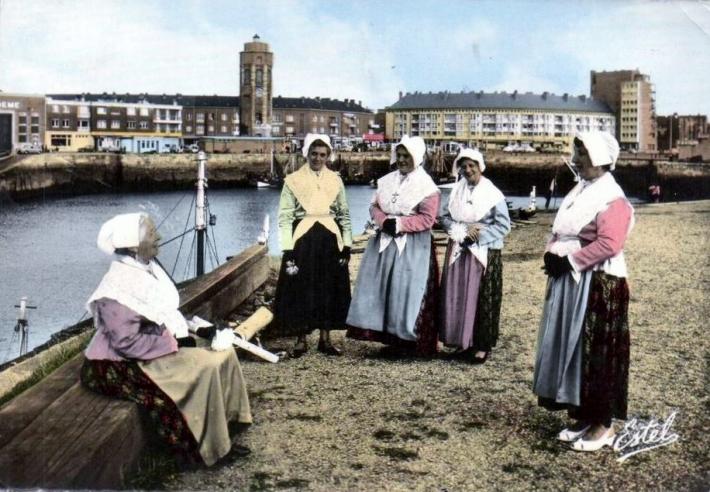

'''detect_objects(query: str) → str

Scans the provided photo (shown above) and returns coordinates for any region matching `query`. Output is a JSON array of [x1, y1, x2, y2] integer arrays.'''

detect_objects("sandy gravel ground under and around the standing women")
[[162, 201, 710, 491]]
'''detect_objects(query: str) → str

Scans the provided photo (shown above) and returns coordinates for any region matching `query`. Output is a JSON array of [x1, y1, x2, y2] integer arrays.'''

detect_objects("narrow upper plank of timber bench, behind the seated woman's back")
[[0, 354, 84, 446]]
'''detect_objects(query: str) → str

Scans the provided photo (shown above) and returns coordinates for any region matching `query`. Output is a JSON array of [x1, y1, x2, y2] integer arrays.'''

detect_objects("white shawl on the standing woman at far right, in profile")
[[547, 172, 634, 282]]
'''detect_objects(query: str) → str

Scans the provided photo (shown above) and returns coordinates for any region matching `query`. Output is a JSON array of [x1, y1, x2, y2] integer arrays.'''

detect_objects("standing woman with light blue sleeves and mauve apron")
[[439, 149, 510, 364]]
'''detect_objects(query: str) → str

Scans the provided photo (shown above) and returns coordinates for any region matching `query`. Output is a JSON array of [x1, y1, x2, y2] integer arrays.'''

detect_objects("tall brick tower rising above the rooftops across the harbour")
[[239, 34, 274, 137]]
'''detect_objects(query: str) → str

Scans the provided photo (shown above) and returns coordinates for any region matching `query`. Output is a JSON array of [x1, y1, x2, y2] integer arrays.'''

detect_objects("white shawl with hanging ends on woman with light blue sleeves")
[[449, 176, 505, 270]]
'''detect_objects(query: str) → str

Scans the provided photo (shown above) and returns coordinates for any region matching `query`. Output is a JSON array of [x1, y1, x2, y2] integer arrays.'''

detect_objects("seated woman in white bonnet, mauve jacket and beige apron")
[[81, 213, 251, 466]]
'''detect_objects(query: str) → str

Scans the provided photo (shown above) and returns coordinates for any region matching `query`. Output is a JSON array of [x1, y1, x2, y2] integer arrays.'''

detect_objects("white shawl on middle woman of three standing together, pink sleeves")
[[373, 167, 439, 254]]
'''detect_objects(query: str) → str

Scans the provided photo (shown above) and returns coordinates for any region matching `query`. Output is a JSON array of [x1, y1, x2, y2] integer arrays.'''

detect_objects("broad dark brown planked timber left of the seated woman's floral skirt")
[[0, 383, 145, 488]]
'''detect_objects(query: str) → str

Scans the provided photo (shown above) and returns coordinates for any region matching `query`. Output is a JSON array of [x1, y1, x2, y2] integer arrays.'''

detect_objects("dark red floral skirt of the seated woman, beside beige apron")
[[81, 359, 202, 463]]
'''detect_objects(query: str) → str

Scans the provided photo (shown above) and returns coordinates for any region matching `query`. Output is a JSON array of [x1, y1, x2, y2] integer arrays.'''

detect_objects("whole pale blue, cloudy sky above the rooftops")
[[0, 0, 710, 114]]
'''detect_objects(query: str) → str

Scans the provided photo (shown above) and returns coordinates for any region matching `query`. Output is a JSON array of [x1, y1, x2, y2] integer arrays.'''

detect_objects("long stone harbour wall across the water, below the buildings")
[[0, 152, 710, 200]]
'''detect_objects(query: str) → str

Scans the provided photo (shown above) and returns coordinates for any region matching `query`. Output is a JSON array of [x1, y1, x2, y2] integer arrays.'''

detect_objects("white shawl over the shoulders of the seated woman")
[[86, 256, 188, 338]]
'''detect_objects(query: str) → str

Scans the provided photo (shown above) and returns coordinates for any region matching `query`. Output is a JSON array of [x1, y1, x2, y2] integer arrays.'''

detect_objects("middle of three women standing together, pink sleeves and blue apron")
[[347, 136, 439, 355]]
